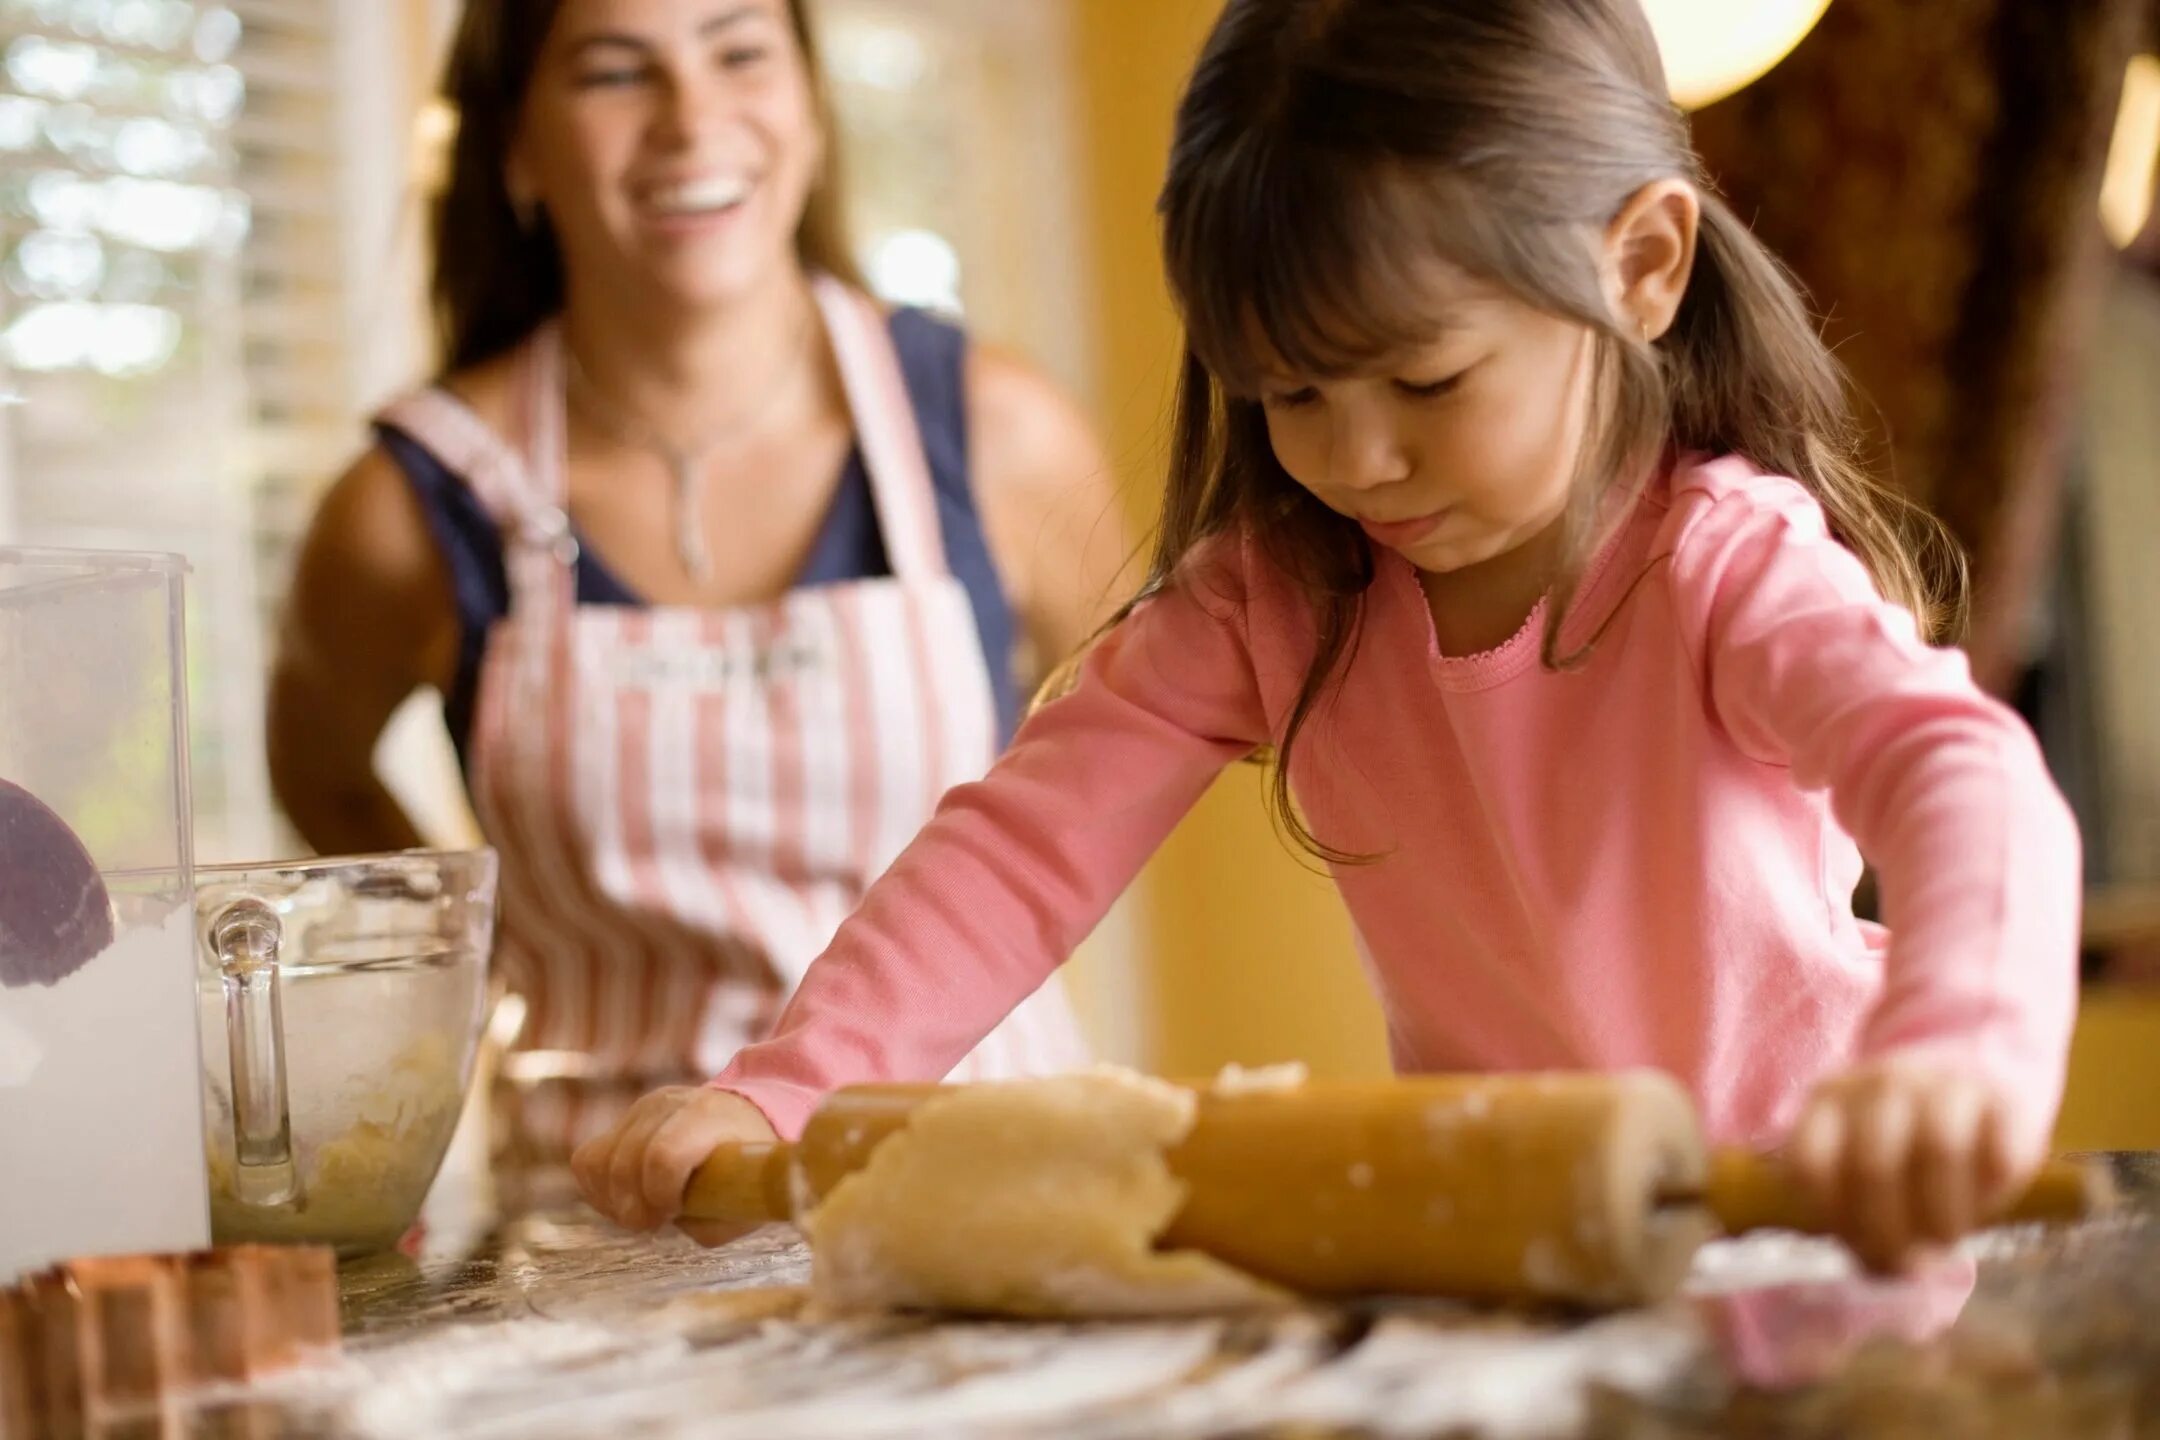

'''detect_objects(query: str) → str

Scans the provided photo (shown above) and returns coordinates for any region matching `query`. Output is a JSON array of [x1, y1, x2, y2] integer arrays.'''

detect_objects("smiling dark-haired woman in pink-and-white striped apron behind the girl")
[[272, 0, 1123, 1159]]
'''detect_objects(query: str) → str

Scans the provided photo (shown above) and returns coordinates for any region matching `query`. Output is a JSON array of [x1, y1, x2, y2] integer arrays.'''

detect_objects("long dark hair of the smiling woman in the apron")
[[430, 0, 858, 371]]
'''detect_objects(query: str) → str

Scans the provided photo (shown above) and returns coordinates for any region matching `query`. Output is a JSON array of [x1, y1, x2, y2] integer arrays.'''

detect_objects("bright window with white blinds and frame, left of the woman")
[[0, 0, 434, 859]]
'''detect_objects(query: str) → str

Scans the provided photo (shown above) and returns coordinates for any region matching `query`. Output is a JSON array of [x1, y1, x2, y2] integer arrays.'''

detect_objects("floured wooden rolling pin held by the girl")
[[683, 1071, 2108, 1306]]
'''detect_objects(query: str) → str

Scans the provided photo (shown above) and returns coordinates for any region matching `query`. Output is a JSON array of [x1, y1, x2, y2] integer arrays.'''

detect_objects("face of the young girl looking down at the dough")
[[1259, 268, 1594, 574]]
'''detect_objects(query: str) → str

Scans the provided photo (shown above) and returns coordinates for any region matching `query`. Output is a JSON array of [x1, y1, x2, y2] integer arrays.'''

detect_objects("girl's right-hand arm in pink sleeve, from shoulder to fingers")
[[1674, 479, 2082, 1259]]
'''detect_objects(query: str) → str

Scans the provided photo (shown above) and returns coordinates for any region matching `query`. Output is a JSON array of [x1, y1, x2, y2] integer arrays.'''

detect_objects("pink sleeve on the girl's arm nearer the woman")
[[713, 542, 1266, 1136]]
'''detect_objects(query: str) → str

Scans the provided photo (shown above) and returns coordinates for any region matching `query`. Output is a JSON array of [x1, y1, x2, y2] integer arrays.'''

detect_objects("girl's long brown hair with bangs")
[[1128, 0, 1963, 861]]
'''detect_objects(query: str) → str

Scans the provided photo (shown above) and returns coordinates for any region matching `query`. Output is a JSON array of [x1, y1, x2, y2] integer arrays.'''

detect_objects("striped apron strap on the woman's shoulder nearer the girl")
[[810, 274, 948, 581]]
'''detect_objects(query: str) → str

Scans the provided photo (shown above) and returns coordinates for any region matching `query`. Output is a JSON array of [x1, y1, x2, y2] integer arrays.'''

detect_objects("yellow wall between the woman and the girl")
[[1071, 0, 1387, 1075]]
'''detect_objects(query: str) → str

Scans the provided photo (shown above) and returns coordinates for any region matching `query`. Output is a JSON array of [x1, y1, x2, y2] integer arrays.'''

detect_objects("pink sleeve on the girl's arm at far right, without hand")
[[1674, 479, 2082, 1153]]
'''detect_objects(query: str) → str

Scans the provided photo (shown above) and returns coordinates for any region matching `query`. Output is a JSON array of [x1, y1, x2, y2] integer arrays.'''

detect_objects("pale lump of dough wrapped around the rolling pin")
[[804, 1069, 1292, 1319]]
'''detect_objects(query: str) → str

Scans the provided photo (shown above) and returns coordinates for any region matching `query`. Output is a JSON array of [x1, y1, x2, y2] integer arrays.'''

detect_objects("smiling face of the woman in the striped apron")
[[505, 0, 825, 307]]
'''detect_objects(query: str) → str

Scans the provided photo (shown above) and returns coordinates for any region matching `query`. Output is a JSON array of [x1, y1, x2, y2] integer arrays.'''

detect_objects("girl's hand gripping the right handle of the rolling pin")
[[1786, 1056, 2043, 1274]]
